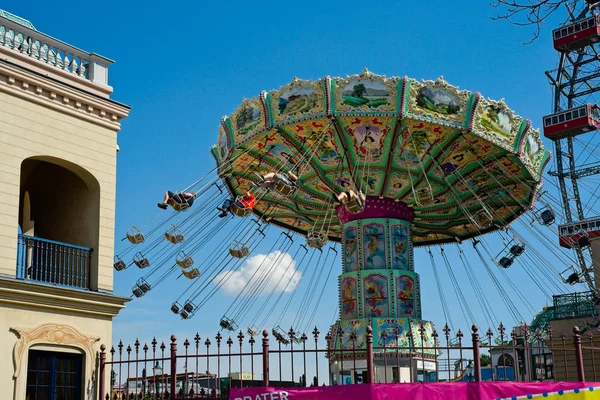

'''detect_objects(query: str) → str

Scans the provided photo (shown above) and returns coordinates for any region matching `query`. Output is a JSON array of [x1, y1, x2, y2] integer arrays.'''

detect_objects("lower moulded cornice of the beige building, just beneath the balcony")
[[0, 277, 130, 318]]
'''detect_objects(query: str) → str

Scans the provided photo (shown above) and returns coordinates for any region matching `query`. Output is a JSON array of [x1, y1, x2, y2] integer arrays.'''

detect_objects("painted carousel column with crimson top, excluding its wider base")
[[337, 197, 421, 320]]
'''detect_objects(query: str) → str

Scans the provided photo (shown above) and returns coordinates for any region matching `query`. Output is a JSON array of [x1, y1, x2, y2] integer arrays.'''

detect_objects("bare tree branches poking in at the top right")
[[490, 0, 585, 44]]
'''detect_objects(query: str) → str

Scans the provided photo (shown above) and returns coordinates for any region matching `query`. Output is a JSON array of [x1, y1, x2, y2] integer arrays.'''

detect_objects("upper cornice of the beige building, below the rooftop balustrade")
[[0, 61, 129, 132]]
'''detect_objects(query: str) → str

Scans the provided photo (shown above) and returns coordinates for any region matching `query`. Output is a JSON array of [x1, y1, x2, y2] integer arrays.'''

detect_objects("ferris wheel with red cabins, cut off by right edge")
[[543, 0, 600, 299]]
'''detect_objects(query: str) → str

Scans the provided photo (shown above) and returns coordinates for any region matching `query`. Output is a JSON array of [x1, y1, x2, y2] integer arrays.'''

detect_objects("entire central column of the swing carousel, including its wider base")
[[330, 197, 436, 383]]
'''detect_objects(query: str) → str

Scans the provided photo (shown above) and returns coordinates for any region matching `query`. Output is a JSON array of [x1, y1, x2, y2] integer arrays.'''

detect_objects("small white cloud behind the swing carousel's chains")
[[216, 251, 302, 295]]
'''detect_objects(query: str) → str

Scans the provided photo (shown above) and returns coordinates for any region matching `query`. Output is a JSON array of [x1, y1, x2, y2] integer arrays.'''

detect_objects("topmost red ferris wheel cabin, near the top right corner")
[[552, 15, 600, 52]]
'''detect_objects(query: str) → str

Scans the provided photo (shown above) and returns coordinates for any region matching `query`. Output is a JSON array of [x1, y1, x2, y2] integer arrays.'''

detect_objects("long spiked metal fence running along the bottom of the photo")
[[99, 324, 600, 400]]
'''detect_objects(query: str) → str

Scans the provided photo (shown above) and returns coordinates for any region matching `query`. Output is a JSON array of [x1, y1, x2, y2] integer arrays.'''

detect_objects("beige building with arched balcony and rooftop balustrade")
[[0, 10, 129, 400]]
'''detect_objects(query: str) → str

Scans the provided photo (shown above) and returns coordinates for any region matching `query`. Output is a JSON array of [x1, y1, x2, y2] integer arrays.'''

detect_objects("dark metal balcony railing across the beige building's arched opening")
[[17, 235, 92, 289]]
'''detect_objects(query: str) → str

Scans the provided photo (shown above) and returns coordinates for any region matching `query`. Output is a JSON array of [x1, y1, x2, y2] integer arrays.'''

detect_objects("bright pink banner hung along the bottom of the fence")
[[229, 382, 600, 400]]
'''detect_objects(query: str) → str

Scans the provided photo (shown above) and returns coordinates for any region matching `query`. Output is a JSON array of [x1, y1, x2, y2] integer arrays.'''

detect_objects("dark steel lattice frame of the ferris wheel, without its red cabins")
[[545, 4, 600, 297]]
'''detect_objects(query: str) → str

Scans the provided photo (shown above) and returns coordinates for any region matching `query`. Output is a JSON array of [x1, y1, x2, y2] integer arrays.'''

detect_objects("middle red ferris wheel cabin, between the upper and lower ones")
[[544, 104, 600, 140]]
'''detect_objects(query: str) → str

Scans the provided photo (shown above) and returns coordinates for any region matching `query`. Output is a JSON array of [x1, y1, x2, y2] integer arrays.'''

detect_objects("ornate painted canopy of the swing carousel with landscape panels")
[[212, 70, 550, 246]]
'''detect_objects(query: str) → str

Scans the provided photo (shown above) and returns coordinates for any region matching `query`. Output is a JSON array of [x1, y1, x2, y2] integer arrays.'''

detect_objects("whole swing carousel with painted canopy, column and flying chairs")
[[114, 70, 596, 357]]
